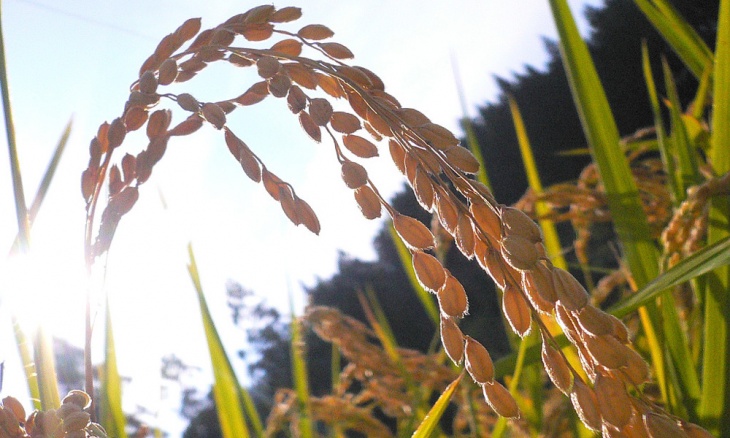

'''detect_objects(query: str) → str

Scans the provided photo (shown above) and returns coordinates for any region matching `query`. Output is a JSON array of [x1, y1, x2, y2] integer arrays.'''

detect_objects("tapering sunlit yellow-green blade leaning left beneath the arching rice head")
[[188, 244, 249, 438]]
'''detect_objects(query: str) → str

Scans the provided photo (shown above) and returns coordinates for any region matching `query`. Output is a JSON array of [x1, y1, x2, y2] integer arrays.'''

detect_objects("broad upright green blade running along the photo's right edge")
[[699, 0, 730, 436]]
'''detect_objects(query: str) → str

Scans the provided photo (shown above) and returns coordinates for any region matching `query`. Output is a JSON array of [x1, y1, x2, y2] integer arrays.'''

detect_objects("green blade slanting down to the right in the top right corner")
[[634, 0, 712, 79]]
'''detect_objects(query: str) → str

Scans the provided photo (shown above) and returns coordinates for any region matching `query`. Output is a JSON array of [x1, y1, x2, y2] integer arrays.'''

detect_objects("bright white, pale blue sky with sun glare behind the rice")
[[0, 0, 601, 434]]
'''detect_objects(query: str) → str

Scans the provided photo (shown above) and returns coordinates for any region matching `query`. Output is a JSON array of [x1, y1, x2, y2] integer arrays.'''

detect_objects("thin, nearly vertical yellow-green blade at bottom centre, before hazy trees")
[[289, 294, 314, 438]]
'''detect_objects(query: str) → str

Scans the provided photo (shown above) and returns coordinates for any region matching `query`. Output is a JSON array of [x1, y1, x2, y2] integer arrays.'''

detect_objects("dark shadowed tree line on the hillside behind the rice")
[[185, 0, 719, 438]]
